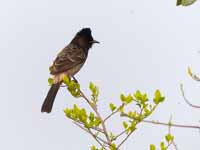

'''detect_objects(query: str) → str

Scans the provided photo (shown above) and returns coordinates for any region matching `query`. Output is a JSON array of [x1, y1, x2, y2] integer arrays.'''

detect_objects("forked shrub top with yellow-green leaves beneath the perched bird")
[[64, 77, 165, 150]]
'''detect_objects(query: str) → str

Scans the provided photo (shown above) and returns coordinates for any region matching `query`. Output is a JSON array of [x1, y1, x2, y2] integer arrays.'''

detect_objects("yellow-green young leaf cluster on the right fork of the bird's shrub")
[[121, 90, 165, 134]]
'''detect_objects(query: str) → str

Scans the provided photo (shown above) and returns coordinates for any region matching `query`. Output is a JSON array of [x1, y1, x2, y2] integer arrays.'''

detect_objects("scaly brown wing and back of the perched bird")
[[50, 44, 87, 75]]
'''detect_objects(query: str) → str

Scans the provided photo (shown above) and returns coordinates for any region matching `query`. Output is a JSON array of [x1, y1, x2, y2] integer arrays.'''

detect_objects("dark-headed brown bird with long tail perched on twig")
[[41, 28, 99, 113]]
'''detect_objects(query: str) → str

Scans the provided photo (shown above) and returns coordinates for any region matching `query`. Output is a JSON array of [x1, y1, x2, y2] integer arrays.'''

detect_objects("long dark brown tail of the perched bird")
[[41, 82, 62, 113]]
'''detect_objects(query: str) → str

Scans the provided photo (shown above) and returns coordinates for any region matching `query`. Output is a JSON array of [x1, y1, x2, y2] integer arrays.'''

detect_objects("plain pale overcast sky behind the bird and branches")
[[0, 0, 200, 150]]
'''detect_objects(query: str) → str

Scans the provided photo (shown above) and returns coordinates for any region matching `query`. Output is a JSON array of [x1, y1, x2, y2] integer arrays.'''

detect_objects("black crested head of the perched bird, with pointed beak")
[[71, 28, 99, 50]]
